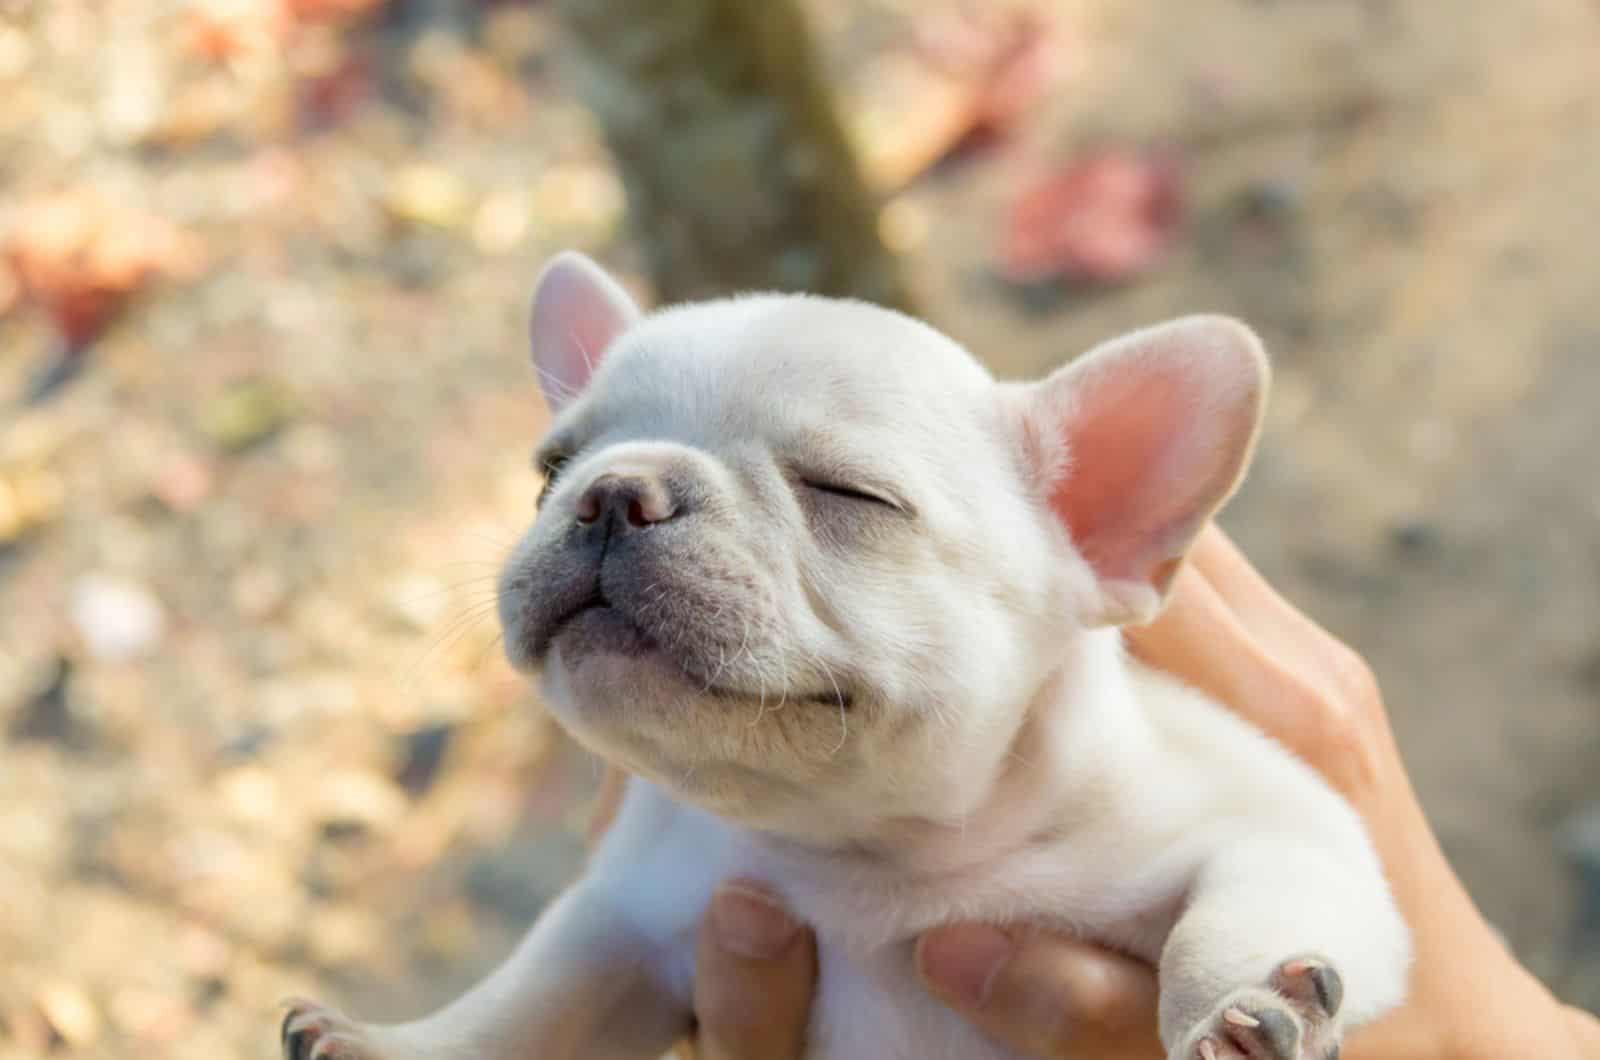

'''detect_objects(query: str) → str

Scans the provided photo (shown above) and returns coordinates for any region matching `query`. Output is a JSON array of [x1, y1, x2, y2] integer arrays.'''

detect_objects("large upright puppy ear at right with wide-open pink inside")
[[1026, 315, 1269, 624]]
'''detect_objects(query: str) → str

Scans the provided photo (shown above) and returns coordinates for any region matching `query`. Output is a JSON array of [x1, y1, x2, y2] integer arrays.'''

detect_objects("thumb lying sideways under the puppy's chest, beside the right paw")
[[917, 924, 1165, 1060]]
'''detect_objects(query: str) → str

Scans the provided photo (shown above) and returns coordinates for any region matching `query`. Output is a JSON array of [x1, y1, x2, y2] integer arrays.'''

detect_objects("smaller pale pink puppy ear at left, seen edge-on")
[[528, 250, 638, 413]]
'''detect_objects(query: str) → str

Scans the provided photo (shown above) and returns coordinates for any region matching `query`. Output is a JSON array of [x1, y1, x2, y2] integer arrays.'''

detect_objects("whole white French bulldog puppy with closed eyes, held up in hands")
[[283, 253, 1410, 1060]]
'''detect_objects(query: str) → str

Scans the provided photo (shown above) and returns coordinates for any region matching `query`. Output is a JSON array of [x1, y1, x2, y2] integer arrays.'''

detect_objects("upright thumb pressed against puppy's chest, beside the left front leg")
[[694, 881, 816, 1060]]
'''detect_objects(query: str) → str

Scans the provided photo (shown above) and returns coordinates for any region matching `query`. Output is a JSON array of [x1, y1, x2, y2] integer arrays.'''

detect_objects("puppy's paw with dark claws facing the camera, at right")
[[1173, 956, 1344, 1060]]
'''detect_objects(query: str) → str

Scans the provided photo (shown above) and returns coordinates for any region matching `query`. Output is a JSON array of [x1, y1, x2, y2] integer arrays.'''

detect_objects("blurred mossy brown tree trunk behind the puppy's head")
[[560, 0, 910, 309]]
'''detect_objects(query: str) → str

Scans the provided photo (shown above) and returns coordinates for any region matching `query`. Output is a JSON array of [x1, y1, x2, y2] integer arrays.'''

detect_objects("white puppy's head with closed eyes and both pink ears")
[[499, 255, 1266, 841]]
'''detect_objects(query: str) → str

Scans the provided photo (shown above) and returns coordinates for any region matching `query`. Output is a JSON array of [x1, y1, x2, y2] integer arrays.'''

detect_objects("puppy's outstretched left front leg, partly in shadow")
[[282, 877, 690, 1060]]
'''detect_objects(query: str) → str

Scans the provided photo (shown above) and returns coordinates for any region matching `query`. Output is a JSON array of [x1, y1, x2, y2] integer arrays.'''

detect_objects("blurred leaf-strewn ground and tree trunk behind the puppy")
[[0, 0, 1600, 1060]]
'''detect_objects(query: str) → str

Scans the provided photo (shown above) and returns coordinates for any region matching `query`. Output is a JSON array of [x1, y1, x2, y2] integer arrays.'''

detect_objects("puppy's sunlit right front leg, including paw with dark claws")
[[1160, 837, 1410, 1060]]
